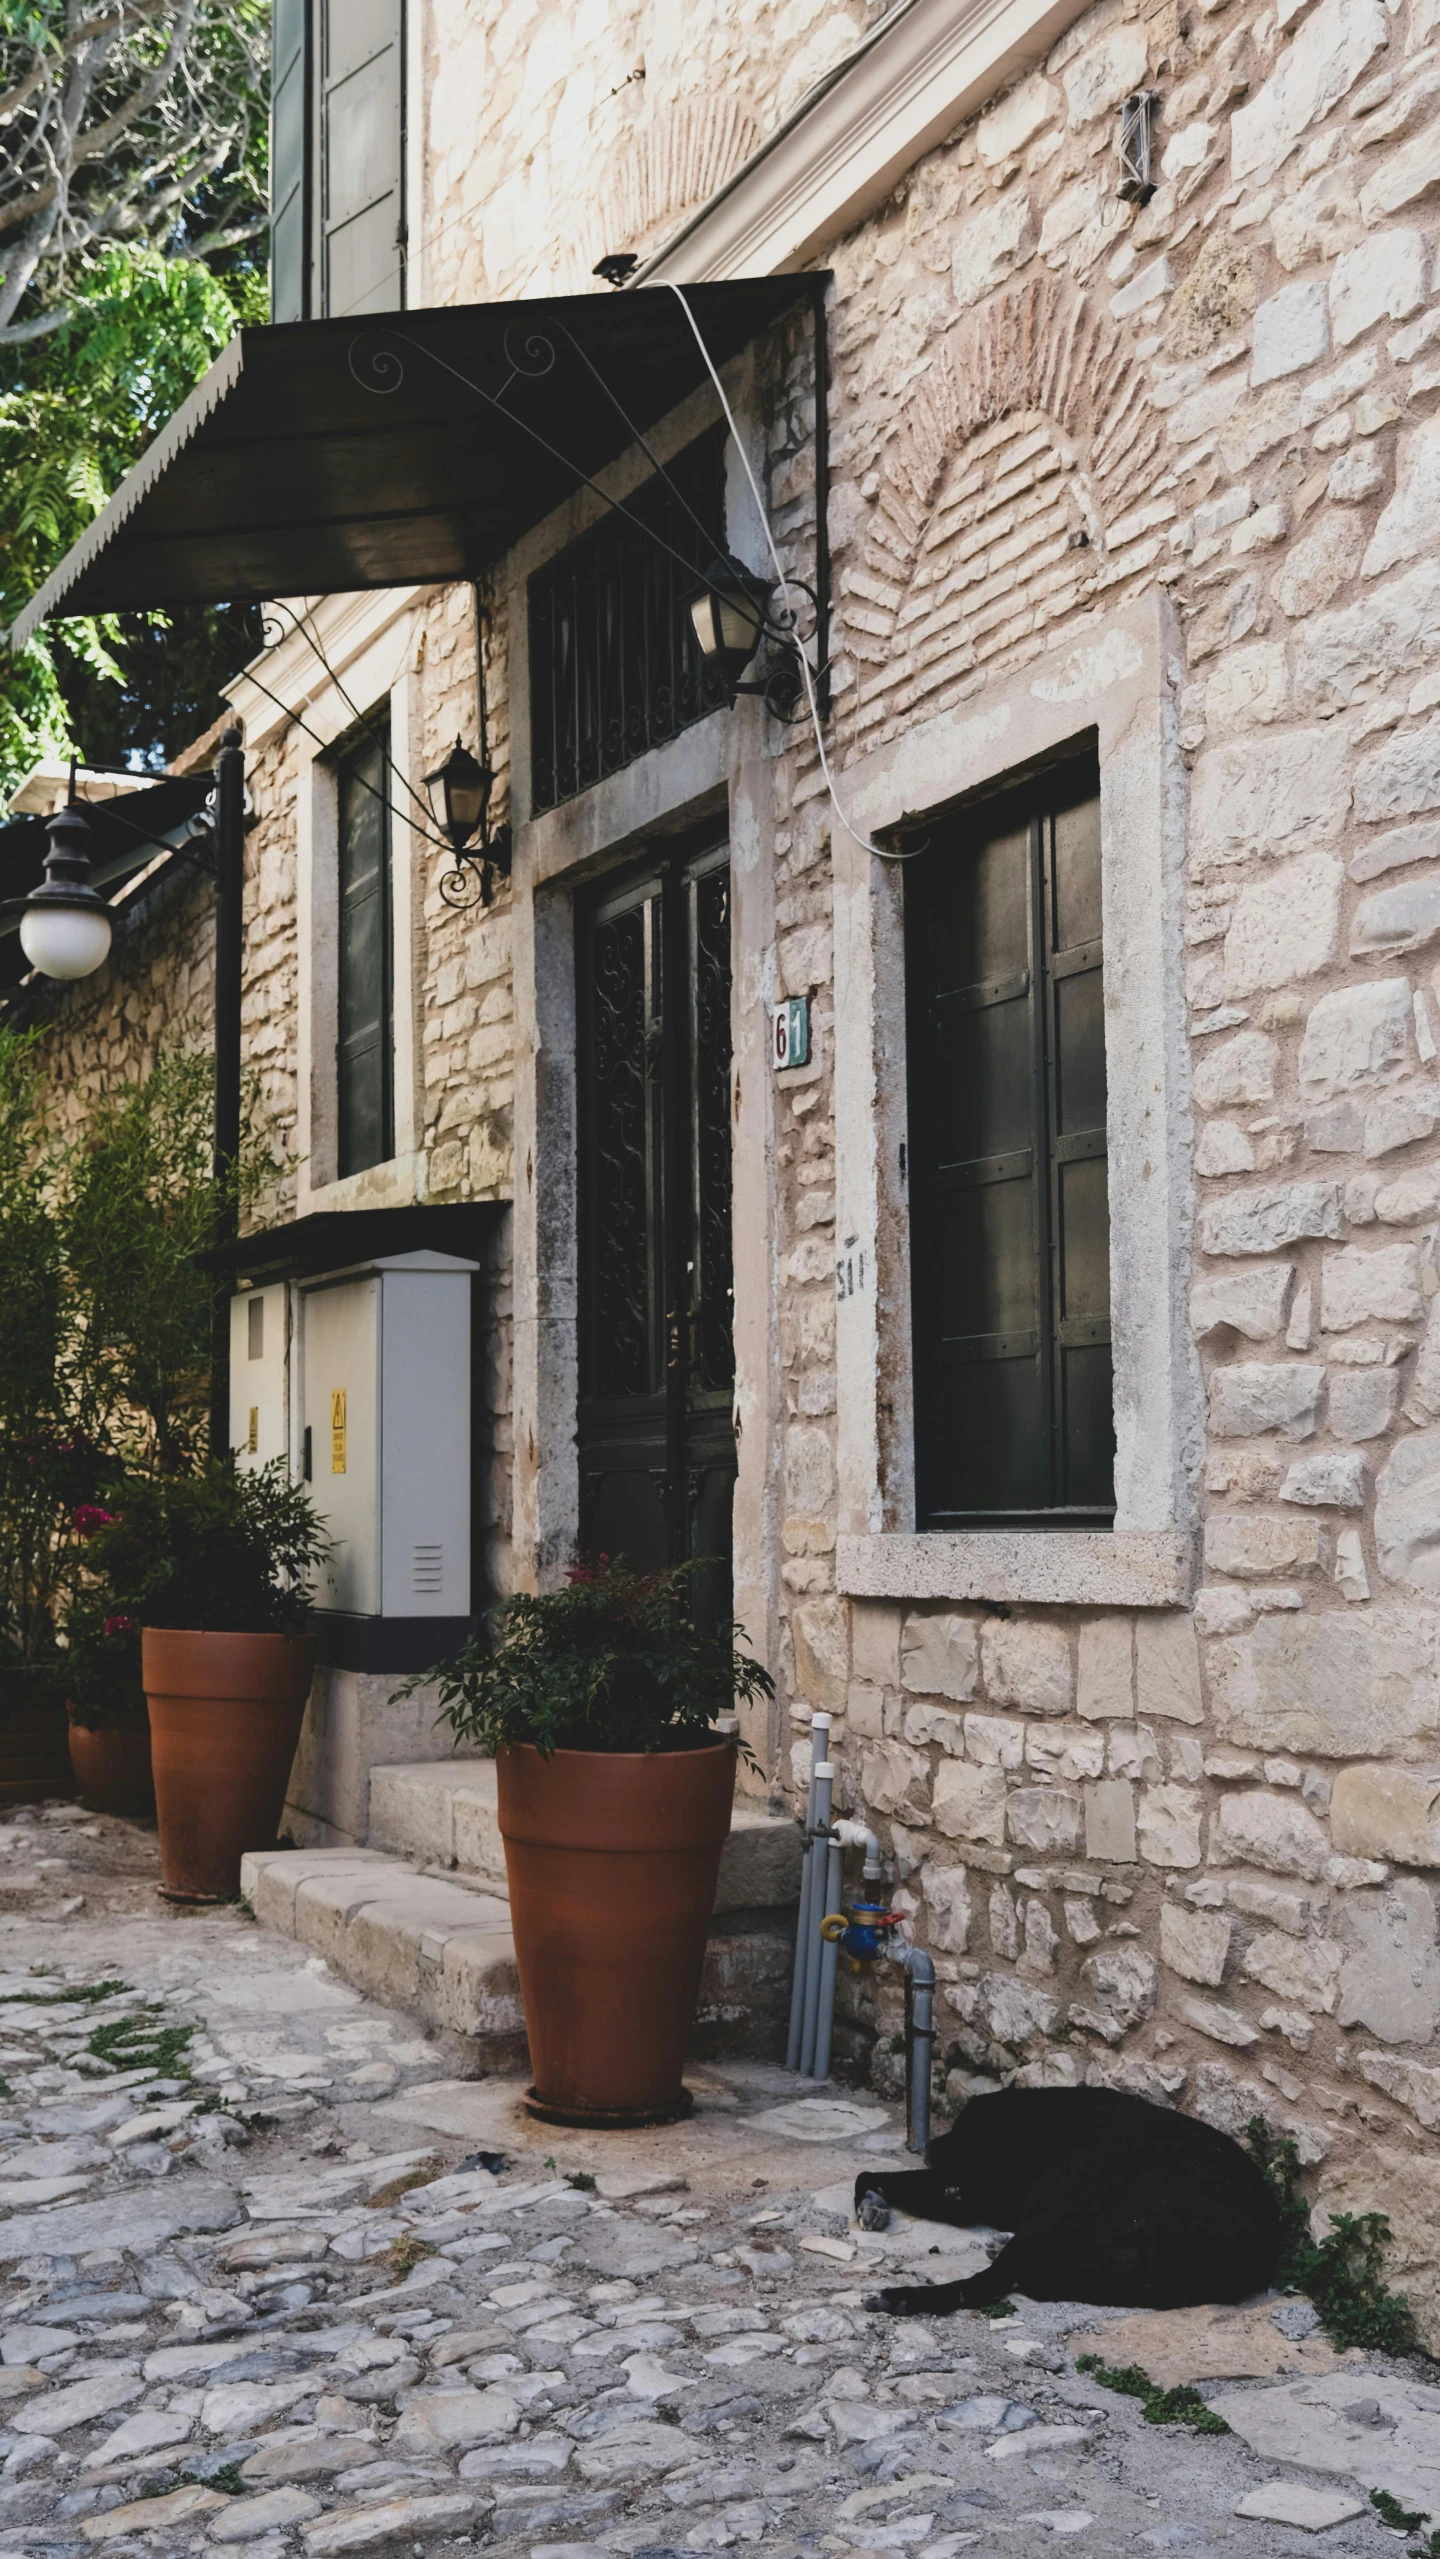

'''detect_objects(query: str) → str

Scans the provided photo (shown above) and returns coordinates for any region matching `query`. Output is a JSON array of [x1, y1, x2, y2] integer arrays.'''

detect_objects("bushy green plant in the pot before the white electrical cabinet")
[[87, 1459, 330, 1635]]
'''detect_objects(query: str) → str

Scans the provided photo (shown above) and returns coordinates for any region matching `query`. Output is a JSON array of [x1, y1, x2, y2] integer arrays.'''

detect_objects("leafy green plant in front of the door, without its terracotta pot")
[[399, 1556, 775, 1758]]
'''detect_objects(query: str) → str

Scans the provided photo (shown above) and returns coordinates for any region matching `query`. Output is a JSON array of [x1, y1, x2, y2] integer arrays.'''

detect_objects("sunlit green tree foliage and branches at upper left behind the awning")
[[0, 0, 271, 796]]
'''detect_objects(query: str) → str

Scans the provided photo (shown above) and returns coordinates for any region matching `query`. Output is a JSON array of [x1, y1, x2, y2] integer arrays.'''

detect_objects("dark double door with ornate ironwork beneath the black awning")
[[575, 842, 734, 1617]]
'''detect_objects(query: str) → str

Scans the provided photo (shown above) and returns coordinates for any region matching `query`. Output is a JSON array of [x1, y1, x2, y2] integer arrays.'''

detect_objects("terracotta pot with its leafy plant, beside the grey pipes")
[[412, 1556, 775, 2127]]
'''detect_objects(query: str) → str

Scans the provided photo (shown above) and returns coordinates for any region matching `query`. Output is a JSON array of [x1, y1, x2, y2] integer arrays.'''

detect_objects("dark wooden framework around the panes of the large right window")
[[903, 737, 1115, 1535]]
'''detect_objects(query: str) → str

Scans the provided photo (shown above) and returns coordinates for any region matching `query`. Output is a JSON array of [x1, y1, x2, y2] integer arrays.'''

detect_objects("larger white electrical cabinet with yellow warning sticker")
[[299, 1251, 476, 1617]]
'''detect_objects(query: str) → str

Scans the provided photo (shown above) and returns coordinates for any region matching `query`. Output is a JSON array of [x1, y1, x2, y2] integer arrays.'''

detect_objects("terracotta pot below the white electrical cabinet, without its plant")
[[141, 1625, 315, 1901]]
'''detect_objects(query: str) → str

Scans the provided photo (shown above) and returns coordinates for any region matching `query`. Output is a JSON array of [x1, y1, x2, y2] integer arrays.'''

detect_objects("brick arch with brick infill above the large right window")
[[841, 274, 1166, 752]]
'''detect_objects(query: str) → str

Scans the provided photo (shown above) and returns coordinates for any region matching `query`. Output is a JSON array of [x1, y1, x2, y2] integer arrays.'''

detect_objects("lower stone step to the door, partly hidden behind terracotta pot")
[[240, 1848, 795, 2070]]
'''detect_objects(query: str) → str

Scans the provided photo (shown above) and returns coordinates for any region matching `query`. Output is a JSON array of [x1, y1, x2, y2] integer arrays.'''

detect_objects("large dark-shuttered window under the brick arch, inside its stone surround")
[[905, 757, 1120, 1528]]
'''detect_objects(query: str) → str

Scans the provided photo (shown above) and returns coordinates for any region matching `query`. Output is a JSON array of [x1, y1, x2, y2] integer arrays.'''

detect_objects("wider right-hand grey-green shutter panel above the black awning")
[[320, 0, 404, 320]]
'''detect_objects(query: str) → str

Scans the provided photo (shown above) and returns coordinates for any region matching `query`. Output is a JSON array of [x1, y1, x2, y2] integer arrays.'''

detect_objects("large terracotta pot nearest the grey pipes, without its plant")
[[496, 1743, 734, 2127]]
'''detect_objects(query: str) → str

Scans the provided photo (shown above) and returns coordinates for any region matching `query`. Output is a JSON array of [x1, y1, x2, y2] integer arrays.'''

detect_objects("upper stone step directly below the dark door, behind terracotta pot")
[[368, 1758, 801, 1912]]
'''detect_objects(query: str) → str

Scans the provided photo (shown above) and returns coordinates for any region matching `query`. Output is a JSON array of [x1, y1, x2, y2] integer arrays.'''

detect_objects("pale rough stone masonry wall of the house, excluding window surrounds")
[[19, 0, 1440, 2344]]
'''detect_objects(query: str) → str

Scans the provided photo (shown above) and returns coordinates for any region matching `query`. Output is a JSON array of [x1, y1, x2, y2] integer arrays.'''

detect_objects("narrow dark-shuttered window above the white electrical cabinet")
[[335, 729, 394, 1175]]
